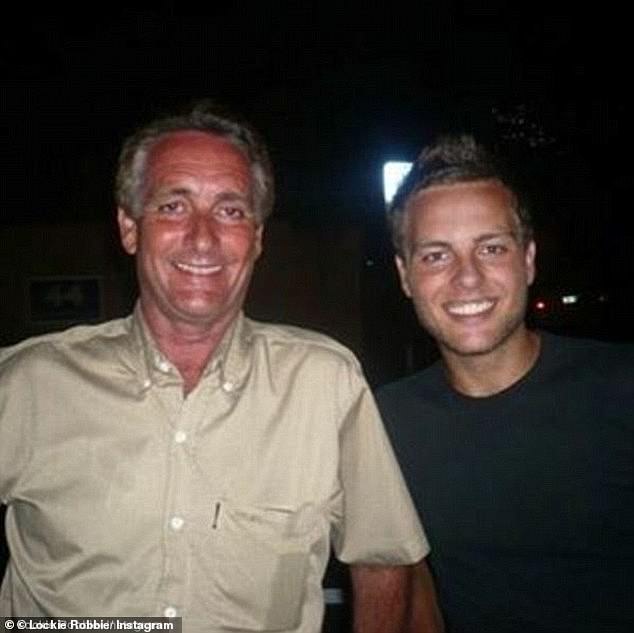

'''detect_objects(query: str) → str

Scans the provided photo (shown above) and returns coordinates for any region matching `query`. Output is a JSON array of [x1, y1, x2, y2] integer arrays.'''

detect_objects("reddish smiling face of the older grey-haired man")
[[119, 131, 262, 332]]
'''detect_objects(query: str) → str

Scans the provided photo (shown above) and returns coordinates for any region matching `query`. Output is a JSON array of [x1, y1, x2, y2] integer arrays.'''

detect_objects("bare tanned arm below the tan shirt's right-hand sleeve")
[[351, 561, 444, 633]]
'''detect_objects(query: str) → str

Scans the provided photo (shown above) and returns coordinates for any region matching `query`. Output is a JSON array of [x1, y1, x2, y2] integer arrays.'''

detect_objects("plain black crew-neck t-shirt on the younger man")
[[377, 333, 634, 633]]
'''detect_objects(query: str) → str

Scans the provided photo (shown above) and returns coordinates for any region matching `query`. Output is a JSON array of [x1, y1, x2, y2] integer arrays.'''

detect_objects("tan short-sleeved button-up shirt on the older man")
[[0, 310, 427, 633]]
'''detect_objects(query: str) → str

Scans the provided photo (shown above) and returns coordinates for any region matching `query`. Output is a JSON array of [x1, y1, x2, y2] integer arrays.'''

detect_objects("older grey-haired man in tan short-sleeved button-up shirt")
[[0, 104, 435, 633]]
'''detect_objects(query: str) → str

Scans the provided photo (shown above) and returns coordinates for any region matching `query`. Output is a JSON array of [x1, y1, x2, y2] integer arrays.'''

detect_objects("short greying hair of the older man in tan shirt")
[[115, 99, 275, 222]]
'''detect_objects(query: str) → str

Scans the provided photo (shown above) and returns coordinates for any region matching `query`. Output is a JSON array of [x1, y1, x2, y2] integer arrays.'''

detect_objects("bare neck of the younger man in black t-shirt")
[[443, 327, 541, 398]]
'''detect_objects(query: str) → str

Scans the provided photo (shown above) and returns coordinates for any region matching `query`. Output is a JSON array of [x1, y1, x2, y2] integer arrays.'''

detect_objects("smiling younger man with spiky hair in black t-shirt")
[[379, 137, 634, 633]]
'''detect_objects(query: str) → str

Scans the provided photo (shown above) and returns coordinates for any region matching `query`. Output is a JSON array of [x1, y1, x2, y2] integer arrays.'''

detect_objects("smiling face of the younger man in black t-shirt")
[[396, 180, 535, 357]]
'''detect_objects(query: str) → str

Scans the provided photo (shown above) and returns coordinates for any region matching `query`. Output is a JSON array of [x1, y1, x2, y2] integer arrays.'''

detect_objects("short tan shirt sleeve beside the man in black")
[[333, 360, 429, 565]]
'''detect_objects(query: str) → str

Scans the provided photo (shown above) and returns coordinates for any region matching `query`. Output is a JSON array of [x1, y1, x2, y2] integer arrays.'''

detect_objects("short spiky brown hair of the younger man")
[[387, 134, 533, 255]]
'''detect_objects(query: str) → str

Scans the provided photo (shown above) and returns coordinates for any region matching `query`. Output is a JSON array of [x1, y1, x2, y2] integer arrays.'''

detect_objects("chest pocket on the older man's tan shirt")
[[214, 502, 316, 631]]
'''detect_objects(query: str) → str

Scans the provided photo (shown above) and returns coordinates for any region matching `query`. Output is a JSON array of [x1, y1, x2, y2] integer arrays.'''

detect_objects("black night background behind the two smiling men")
[[0, 0, 634, 628]]
